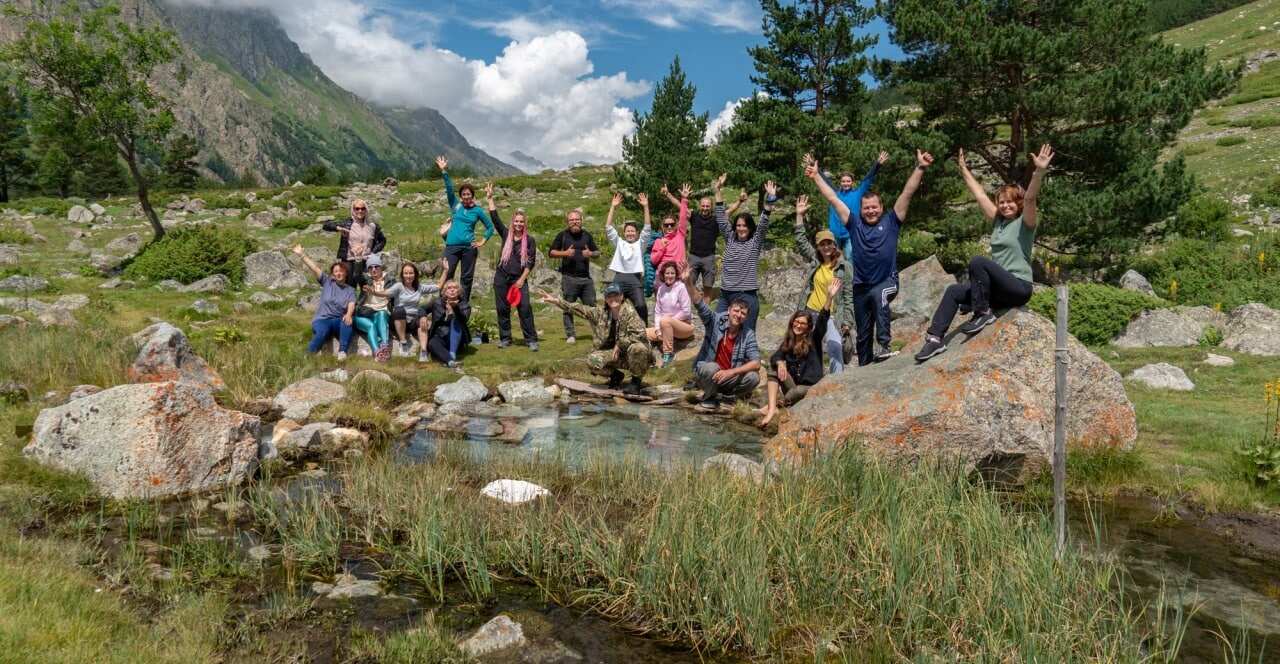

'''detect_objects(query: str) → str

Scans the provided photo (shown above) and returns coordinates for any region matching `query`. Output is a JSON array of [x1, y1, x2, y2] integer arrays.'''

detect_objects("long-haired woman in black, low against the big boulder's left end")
[[759, 278, 841, 427]]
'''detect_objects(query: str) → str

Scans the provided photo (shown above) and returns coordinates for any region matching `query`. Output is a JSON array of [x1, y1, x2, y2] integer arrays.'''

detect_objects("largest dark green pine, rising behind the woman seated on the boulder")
[[883, 0, 1238, 261]]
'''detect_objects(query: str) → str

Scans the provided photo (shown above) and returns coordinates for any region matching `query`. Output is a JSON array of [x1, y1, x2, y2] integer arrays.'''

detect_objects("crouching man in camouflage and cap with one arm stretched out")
[[538, 284, 653, 394]]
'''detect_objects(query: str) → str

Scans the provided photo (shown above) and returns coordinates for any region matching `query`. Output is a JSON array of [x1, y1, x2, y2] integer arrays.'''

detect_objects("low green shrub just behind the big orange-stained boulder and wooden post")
[[1028, 284, 1162, 345]]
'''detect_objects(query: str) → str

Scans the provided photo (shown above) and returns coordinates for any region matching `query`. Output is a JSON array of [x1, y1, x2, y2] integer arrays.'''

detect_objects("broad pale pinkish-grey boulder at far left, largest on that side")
[[23, 381, 259, 499]]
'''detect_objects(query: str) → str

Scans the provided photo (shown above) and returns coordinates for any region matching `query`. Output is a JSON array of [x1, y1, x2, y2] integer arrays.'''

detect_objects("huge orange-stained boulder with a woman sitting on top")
[[765, 310, 1138, 481]]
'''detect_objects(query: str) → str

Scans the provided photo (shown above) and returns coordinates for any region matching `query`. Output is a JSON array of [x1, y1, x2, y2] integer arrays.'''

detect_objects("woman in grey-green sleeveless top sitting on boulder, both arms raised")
[[915, 143, 1053, 362]]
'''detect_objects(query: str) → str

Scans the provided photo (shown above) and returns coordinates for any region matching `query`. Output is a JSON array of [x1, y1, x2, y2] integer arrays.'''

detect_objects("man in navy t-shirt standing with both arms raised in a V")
[[805, 150, 933, 366]]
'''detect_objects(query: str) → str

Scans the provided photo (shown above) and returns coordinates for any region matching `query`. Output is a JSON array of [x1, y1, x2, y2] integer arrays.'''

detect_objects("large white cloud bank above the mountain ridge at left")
[[163, 0, 650, 168]]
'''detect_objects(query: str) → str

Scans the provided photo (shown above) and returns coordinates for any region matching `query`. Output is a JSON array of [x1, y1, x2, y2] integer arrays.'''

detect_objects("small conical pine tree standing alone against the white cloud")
[[614, 58, 708, 206]]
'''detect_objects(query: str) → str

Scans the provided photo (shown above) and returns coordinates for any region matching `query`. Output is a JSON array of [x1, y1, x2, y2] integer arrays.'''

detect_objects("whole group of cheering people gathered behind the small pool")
[[302, 145, 1053, 426]]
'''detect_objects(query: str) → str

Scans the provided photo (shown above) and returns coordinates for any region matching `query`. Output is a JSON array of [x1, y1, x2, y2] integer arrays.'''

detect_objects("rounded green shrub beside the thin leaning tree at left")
[[124, 225, 256, 285]]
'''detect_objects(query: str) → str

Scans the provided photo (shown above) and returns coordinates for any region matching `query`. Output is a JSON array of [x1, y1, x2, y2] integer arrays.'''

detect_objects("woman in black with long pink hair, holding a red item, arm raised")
[[484, 182, 538, 353]]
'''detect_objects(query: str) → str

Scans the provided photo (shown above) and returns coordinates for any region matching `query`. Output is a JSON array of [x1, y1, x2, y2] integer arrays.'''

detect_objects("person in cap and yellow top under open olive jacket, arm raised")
[[792, 194, 854, 374]]
